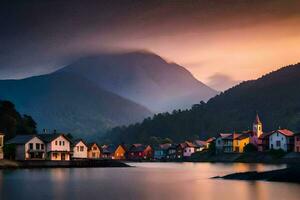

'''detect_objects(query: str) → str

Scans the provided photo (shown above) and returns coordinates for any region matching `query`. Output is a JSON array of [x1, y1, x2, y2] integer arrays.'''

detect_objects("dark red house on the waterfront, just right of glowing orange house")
[[128, 144, 153, 160]]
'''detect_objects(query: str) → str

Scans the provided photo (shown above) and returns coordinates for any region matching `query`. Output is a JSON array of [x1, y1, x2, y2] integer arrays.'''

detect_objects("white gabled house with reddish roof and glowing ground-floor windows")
[[39, 133, 71, 160]]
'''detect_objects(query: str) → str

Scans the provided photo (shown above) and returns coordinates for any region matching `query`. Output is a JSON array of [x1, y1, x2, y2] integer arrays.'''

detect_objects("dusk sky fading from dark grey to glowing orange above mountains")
[[0, 0, 300, 91]]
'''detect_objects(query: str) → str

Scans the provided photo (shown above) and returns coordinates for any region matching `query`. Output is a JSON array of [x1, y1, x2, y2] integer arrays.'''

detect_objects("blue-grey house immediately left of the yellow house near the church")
[[216, 133, 233, 154]]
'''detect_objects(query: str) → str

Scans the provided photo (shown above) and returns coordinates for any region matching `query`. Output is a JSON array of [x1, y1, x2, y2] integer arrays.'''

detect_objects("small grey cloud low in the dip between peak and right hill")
[[207, 73, 240, 91]]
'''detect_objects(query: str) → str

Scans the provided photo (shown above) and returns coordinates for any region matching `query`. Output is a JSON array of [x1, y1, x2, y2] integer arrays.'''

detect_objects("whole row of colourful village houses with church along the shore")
[[0, 115, 300, 161]]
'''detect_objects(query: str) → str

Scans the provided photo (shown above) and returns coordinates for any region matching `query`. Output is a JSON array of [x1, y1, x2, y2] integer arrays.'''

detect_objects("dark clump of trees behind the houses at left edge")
[[0, 100, 37, 140]]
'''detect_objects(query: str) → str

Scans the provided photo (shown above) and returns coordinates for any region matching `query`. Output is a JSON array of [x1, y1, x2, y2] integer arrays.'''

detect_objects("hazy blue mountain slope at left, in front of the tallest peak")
[[0, 73, 151, 138]]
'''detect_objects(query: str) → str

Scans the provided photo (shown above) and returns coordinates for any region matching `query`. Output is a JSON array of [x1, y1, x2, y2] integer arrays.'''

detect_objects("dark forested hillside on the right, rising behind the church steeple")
[[106, 64, 300, 143]]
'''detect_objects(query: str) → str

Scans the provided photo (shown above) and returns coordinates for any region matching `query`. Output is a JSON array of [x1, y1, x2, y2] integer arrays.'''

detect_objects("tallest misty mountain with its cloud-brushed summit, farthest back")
[[57, 52, 217, 112]]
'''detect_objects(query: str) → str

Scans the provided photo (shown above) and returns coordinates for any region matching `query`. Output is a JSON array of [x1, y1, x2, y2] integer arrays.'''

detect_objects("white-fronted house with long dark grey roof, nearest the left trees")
[[6, 135, 46, 160]]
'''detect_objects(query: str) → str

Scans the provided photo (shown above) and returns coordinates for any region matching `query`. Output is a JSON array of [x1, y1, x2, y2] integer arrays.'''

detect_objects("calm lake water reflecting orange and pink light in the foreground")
[[0, 163, 300, 200]]
